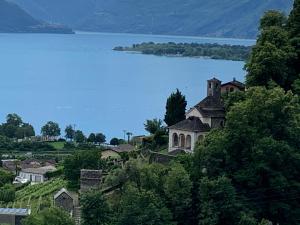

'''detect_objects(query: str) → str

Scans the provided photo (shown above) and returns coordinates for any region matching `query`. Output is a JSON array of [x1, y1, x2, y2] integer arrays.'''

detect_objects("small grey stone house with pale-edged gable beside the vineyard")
[[54, 188, 75, 216]]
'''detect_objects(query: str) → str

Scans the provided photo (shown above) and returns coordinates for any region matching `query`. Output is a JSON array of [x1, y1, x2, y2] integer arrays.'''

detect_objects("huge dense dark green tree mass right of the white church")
[[193, 87, 300, 224]]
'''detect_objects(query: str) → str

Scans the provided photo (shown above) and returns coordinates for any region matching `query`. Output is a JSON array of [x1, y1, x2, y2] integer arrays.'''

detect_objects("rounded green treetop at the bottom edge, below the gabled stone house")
[[22, 208, 75, 225]]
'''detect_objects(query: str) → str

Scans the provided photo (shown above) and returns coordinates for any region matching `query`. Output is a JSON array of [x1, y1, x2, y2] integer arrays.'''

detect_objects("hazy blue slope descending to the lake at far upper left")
[[0, 0, 72, 33]]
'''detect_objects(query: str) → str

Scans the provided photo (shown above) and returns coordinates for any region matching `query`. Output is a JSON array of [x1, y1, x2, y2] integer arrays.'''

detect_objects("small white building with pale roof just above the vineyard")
[[19, 166, 56, 183]]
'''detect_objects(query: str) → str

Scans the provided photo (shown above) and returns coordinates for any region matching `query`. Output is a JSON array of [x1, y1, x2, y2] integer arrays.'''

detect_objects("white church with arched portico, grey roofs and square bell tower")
[[169, 78, 225, 153]]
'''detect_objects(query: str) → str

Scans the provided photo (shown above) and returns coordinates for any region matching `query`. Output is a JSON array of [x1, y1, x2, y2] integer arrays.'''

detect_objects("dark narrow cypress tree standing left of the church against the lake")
[[165, 89, 187, 126]]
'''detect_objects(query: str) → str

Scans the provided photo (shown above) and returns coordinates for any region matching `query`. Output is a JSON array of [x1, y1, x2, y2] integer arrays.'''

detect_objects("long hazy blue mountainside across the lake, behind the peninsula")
[[11, 0, 293, 38]]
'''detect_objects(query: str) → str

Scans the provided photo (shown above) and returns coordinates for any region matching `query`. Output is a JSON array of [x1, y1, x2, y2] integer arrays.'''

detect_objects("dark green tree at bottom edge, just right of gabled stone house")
[[80, 192, 113, 225]]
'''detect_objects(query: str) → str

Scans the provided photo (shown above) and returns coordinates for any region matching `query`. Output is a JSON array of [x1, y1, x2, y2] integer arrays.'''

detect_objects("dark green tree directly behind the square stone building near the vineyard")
[[63, 150, 104, 189]]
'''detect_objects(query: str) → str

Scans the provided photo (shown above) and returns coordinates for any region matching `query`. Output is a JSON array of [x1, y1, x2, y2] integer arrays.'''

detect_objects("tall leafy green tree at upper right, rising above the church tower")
[[245, 11, 297, 90]]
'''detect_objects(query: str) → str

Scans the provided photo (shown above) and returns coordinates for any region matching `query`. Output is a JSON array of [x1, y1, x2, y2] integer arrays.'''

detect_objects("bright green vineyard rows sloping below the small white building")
[[0, 178, 67, 213]]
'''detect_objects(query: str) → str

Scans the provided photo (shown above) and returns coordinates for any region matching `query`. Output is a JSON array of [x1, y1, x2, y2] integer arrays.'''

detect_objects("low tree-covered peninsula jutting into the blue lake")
[[114, 42, 251, 61]]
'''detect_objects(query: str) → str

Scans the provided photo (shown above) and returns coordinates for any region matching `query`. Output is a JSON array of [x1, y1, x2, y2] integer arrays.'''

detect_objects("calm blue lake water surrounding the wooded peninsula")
[[0, 32, 255, 140]]
